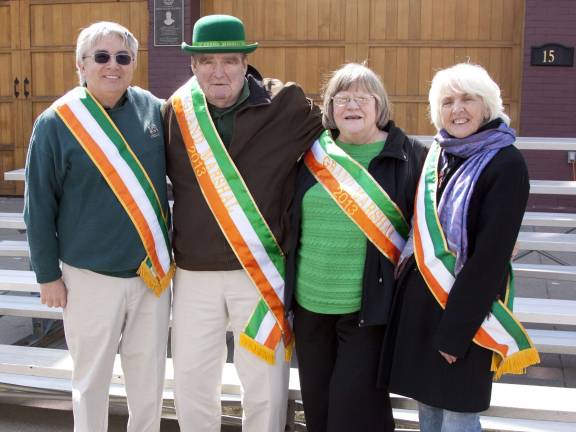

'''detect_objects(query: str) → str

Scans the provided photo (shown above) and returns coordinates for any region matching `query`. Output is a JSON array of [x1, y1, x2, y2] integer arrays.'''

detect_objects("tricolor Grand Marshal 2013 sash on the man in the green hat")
[[172, 77, 292, 364]]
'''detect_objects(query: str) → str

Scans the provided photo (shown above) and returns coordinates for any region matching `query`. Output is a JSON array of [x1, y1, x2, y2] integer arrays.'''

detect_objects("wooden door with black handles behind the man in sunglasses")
[[0, 0, 148, 193]]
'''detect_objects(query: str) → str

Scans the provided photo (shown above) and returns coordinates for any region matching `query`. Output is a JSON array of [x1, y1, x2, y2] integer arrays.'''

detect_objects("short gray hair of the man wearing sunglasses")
[[76, 21, 138, 85]]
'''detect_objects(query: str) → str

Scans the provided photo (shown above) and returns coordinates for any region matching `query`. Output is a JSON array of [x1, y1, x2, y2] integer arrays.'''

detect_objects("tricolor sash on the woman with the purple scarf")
[[414, 142, 540, 379]]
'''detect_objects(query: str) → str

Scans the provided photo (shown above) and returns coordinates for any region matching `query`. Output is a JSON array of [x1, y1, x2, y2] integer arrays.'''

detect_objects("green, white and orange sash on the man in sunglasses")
[[52, 87, 175, 296]]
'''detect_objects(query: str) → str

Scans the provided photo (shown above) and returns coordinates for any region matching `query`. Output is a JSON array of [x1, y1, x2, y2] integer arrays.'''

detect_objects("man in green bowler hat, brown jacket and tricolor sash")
[[164, 15, 322, 432]]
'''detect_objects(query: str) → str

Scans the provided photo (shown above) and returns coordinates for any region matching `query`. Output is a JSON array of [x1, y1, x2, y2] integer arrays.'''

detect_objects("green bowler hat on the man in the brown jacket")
[[182, 15, 258, 54]]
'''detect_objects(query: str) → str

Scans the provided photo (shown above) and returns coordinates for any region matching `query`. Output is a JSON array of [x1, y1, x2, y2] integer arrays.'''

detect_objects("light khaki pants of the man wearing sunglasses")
[[62, 264, 170, 432]]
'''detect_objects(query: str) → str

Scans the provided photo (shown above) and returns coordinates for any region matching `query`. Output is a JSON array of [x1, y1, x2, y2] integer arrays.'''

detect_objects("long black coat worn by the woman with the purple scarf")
[[380, 146, 530, 412]]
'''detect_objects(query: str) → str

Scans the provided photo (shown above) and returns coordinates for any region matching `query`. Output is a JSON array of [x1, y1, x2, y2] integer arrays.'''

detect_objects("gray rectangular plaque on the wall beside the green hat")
[[154, 0, 184, 46]]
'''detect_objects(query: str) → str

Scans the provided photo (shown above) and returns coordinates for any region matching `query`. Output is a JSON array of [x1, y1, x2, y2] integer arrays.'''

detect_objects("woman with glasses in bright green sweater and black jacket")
[[286, 63, 424, 432]]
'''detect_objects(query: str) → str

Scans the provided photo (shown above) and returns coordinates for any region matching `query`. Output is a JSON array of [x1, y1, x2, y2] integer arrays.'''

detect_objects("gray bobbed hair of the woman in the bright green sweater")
[[322, 63, 390, 129]]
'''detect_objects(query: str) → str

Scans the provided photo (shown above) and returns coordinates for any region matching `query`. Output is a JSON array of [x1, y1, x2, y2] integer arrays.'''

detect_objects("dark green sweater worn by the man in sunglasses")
[[24, 87, 168, 283]]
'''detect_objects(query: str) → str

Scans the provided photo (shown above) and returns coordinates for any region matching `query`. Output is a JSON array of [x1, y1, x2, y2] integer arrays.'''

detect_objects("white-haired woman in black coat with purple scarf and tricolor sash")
[[380, 64, 538, 432]]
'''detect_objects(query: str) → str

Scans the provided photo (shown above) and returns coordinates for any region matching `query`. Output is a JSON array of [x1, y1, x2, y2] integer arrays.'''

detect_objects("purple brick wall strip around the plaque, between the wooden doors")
[[148, 0, 200, 98]]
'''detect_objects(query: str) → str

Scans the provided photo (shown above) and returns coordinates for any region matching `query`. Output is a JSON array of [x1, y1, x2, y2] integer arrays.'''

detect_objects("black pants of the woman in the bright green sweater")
[[294, 305, 394, 432]]
